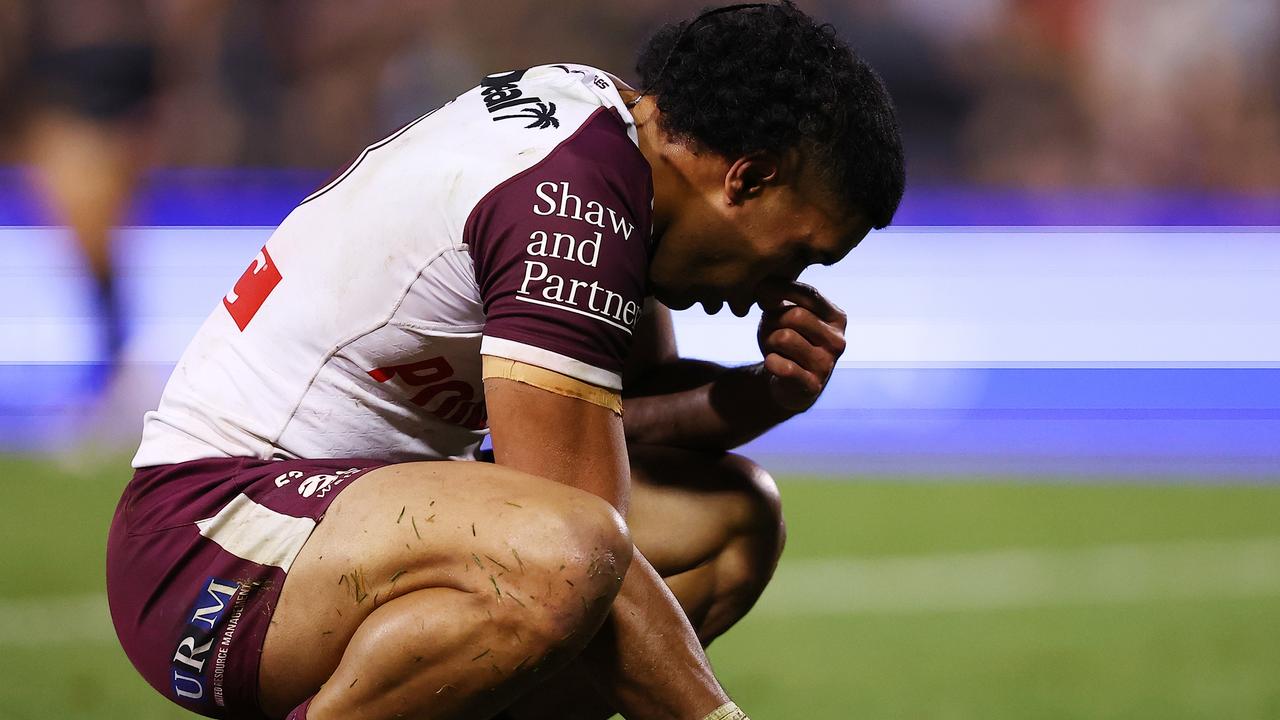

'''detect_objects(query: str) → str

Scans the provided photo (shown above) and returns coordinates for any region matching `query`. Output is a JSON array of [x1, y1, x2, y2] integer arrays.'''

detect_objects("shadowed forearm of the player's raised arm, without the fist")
[[622, 360, 795, 450]]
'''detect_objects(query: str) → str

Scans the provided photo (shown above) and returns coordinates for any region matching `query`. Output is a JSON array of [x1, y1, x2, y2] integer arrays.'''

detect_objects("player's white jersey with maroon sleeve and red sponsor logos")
[[133, 65, 653, 468]]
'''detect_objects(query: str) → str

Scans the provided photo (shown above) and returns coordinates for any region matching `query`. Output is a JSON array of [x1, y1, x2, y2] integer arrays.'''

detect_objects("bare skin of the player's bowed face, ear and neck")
[[621, 90, 872, 322]]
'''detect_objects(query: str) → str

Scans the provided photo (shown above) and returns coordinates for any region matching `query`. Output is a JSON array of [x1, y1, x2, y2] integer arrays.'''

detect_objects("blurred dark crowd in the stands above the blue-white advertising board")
[[0, 0, 1280, 190]]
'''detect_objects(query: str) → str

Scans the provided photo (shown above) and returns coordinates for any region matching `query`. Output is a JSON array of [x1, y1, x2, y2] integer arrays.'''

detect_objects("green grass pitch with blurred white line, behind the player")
[[0, 457, 1280, 720]]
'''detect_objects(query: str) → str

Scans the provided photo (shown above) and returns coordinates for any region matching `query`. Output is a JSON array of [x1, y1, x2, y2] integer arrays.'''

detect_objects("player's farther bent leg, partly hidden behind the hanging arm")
[[499, 446, 786, 720]]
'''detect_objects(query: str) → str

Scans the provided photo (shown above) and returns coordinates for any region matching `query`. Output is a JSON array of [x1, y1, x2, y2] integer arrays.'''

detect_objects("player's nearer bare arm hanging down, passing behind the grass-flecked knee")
[[485, 378, 727, 720]]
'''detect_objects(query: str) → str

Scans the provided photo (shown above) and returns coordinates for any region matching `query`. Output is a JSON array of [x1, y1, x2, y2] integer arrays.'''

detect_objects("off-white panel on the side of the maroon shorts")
[[196, 493, 316, 573]]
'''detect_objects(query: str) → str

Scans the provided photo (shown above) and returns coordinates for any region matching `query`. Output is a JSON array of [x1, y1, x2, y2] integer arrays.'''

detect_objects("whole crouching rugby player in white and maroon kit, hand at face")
[[108, 4, 904, 720]]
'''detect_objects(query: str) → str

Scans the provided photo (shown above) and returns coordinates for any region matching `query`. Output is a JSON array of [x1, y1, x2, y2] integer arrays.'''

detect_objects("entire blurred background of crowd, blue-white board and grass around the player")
[[0, 0, 1280, 719]]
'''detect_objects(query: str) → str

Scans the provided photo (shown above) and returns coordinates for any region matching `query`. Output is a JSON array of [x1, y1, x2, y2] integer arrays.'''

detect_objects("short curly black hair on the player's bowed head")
[[636, 0, 906, 228]]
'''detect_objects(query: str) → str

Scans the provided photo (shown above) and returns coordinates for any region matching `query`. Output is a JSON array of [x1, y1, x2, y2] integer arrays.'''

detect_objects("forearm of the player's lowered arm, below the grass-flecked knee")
[[582, 550, 728, 720]]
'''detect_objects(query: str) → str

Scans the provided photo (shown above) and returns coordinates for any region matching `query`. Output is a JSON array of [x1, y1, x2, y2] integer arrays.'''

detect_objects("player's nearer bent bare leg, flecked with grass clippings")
[[260, 462, 631, 720]]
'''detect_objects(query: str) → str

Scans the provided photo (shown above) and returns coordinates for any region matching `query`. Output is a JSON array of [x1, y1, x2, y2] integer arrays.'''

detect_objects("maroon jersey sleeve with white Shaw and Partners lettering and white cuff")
[[463, 109, 653, 391]]
